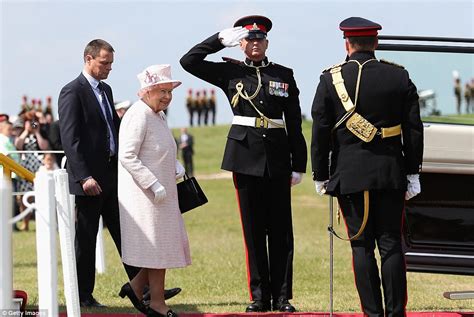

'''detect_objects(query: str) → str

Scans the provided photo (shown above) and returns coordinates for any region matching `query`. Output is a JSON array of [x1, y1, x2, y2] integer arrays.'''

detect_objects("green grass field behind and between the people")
[[13, 122, 474, 313]]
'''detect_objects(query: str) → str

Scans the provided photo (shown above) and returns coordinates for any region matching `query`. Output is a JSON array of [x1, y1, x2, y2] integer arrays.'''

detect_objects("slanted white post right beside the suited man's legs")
[[54, 169, 81, 317]]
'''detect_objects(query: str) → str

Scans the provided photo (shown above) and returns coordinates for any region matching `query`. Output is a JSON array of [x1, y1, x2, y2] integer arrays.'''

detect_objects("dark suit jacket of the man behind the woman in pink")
[[58, 73, 120, 195]]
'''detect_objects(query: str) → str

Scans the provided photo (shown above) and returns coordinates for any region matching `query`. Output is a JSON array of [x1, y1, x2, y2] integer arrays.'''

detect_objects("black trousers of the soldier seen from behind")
[[337, 190, 407, 316]]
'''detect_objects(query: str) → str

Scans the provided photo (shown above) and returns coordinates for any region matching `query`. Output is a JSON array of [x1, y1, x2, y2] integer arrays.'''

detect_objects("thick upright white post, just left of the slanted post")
[[35, 172, 58, 317]]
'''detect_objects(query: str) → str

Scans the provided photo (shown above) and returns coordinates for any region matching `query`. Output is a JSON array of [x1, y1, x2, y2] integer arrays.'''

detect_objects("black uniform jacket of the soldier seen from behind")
[[311, 52, 423, 194]]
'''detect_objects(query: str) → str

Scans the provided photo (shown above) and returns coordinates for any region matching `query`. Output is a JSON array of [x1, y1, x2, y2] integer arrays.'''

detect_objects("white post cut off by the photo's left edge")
[[0, 177, 13, 309]]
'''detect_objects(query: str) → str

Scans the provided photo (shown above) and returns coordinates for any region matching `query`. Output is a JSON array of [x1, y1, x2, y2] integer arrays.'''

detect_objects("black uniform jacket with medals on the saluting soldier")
[[180, 34, 307, 177]]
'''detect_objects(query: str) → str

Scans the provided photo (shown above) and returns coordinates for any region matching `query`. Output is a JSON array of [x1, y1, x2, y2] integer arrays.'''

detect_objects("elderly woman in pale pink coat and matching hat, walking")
[[118, 65, 191, 317]]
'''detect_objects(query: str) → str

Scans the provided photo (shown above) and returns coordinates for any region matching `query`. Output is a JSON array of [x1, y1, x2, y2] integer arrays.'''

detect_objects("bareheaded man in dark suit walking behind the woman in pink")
[[58, 39, 179, 307]]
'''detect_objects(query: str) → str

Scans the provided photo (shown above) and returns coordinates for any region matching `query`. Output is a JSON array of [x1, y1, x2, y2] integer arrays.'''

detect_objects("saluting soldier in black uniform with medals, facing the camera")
[[180, 15, 307, 312]]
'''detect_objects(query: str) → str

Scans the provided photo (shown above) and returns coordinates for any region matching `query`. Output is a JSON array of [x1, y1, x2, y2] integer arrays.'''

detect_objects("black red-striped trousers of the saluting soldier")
[[234, 173, 293, 301]]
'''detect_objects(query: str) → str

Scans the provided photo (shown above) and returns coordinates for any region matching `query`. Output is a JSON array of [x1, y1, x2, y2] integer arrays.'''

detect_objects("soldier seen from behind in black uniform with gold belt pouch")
[[311, 17, 423, 316]]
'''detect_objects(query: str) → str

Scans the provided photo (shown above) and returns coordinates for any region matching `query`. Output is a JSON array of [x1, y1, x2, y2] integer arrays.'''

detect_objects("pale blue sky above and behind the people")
[[0, 0, 474, 127]]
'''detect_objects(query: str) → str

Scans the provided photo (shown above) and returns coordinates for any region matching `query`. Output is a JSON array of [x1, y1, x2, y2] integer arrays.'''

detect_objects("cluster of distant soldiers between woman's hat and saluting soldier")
[[186, 88, 216, 126]]
